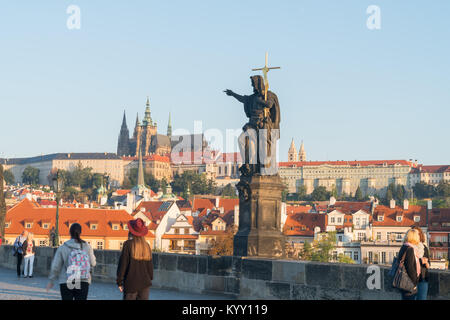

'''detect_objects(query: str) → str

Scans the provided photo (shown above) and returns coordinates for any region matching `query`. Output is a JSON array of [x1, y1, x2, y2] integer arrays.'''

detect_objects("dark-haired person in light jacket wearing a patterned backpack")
[[47, 223, 96, 300]]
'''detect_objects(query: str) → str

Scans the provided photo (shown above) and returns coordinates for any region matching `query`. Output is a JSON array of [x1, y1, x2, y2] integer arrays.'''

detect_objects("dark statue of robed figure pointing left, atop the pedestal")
[[224, 76, 280, 176]]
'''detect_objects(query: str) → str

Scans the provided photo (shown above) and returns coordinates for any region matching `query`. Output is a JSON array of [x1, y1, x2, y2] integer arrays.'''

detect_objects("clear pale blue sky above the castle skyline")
[[0, 0, 450, 165]]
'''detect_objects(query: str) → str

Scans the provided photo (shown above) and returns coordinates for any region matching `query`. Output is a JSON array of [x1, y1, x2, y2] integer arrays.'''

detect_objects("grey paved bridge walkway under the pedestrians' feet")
[[0, 268, 230, 300]]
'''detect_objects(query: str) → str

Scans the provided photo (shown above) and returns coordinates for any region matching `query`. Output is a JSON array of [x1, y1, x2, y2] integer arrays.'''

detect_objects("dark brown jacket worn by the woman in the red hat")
[[117, 240, 153, 293]]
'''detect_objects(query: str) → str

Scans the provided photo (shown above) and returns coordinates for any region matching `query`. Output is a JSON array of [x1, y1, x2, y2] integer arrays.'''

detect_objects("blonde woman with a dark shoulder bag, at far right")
[[398, 229, 421, 300]]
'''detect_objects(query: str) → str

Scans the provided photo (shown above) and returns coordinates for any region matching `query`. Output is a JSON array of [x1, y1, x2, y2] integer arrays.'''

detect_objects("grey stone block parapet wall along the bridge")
[[0, 246, 450, 300]]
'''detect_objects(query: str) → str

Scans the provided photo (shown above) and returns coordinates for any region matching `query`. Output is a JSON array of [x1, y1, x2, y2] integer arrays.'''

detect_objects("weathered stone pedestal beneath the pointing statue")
[[233, 174, 285, 258]]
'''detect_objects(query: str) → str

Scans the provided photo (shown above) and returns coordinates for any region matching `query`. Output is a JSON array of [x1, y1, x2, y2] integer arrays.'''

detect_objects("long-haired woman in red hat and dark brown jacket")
[[117, 218, 153, 300]]
